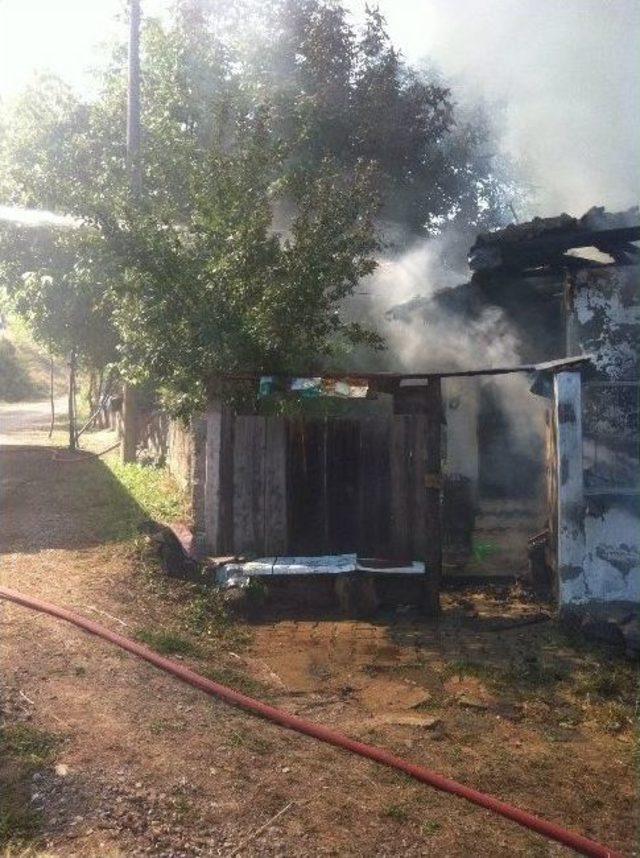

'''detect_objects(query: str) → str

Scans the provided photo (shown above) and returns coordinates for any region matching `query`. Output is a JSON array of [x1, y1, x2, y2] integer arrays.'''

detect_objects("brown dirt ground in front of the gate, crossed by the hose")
[[0, 434, 634, 858]]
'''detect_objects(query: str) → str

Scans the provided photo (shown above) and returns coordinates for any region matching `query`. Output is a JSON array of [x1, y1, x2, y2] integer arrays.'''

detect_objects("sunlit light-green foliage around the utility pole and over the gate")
[[2, 9, 378, 412]]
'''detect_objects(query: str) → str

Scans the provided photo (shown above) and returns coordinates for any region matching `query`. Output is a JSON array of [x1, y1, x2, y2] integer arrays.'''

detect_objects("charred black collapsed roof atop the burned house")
[[469, 206, 640, 273]]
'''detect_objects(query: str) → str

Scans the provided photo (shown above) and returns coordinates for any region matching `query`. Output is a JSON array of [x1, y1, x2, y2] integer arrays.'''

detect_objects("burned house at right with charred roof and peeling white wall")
[[450, 208, 640, 618]]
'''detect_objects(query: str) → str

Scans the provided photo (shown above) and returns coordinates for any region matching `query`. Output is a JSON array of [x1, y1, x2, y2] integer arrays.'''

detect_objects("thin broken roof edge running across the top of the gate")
[[211, 354, 594, 382]]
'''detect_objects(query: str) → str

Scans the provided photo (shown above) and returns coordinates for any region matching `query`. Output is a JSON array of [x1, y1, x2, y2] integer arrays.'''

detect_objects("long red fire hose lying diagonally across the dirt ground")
[[0, 587, 622, 858]]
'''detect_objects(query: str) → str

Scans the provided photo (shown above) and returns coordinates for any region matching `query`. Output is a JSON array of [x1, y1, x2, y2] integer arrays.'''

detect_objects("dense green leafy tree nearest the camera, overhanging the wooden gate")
[[109, 132, 379, 412]]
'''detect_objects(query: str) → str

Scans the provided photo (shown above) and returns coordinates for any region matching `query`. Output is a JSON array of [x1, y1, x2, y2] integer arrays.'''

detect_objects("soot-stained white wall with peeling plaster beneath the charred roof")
[[558, 265, 640, 612]]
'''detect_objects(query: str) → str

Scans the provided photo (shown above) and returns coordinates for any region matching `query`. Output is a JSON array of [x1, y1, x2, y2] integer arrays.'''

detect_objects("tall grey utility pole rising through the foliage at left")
[[121, 0, 142, 462]]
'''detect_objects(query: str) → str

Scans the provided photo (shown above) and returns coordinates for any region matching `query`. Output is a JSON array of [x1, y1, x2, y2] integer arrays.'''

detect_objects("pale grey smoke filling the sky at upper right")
[[350, 0, 640, 216]]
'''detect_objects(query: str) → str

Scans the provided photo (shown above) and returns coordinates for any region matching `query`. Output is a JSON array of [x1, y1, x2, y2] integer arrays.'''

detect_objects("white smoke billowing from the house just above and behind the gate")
[[349, 237, 545, 484]]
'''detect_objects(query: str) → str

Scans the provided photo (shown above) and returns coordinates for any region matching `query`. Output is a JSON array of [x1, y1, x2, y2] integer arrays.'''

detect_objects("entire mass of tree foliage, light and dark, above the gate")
[[0, 0, 520, 408]]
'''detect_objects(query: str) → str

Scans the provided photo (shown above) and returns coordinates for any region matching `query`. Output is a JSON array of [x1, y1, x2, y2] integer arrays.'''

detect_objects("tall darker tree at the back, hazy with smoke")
[[210, 0, 514, 240]]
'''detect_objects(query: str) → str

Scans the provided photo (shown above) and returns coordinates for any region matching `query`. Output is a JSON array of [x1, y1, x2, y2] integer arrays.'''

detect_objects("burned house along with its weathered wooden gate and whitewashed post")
[[132, 204, 640, 632]]
